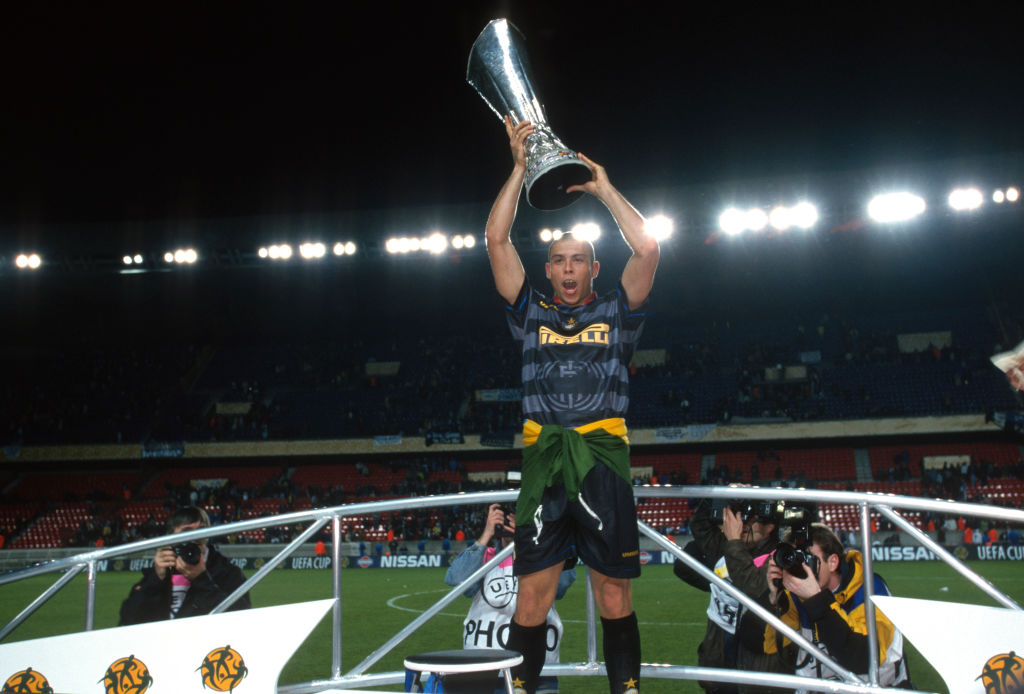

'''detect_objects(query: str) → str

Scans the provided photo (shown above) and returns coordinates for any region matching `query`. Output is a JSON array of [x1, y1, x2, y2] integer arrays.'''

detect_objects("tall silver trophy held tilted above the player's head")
[[466, 19, 593, 210]]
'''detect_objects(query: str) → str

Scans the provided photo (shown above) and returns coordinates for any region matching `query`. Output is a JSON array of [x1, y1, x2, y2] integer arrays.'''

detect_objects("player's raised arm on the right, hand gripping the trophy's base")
[[565, 157, 662, 308]]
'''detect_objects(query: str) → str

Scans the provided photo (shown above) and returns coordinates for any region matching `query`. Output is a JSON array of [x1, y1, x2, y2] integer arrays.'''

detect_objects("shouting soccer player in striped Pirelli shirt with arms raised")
[[486, 117, 659, 694]]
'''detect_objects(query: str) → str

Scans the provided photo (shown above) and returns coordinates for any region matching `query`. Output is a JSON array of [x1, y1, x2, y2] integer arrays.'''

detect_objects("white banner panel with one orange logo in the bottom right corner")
[[874, 596, 1024, 694]]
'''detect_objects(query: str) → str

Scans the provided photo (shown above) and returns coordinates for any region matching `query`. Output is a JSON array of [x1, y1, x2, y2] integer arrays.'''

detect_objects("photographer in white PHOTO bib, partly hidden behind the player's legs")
[[444, 504, 577, 692]]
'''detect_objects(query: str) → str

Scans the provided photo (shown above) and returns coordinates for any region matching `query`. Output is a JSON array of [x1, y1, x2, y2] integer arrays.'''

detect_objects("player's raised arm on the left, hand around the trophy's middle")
[[485, 116, 534, 304]]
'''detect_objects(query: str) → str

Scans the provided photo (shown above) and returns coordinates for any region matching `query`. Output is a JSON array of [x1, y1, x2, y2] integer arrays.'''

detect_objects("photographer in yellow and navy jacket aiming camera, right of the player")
[[765, 523, 913, 689]]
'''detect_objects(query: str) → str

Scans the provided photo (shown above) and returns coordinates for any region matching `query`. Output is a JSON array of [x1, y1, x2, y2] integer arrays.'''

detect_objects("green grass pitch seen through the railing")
[[0, 562, 1024, 694]]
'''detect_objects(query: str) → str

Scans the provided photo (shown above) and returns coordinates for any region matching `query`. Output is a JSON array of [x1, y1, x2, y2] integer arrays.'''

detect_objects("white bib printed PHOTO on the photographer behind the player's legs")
[[462, 547, 562, 662]]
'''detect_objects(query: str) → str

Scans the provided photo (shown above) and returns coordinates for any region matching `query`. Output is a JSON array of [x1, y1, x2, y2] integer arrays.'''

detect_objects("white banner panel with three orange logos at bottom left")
[[0, 599, 334, 694]]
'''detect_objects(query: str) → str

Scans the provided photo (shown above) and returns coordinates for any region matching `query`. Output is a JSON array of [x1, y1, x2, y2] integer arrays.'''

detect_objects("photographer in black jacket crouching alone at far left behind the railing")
[[120, 506, 250, 625]]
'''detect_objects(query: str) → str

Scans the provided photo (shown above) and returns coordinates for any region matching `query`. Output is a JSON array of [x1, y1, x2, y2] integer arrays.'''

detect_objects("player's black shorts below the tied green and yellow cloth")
[[513, 463, 640, 578]]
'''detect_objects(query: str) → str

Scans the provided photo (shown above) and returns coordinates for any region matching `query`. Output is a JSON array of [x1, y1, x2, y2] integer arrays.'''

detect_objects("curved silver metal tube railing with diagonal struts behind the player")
[[0, 485, 1024, 694]]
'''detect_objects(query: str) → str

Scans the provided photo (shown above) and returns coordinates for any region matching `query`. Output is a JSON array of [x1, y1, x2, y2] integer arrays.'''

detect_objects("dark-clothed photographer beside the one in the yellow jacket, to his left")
[[674, 498, 793, 694]]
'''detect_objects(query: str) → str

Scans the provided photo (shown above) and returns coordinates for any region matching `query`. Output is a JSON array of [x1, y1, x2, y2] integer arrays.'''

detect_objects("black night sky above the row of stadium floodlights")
[[0, 2, 1024, 243]]
